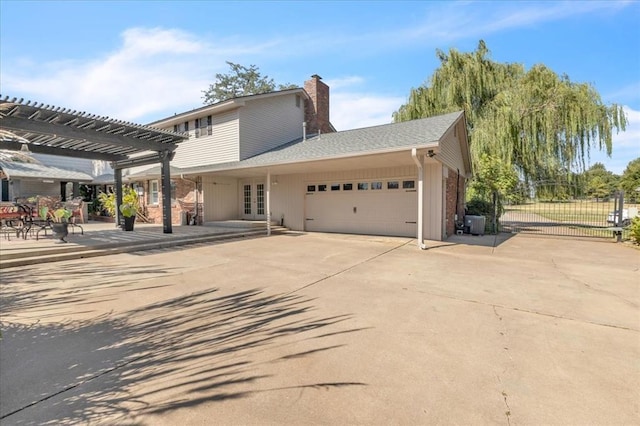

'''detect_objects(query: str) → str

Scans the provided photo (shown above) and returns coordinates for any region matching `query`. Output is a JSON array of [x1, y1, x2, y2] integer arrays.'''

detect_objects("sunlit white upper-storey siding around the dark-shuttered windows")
[[170, 110, 240, 167]]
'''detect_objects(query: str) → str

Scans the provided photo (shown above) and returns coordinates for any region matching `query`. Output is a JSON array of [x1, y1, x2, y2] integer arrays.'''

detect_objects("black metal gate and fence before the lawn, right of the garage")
[[499, 185, 638, 238]]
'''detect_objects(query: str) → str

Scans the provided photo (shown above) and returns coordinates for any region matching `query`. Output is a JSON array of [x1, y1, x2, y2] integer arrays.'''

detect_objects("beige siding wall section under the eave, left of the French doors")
[[202, 177, 239, 222]]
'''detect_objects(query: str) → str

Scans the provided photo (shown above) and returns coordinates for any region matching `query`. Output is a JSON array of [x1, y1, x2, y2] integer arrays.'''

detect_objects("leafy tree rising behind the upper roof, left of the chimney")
[[202, 61, 297, 105]]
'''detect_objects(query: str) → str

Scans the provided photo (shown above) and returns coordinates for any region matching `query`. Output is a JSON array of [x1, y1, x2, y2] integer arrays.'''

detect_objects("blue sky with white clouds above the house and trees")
[[0, 0, 640, 174]]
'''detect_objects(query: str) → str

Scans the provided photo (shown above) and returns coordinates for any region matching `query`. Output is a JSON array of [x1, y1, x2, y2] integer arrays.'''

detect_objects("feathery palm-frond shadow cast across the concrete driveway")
[[0, 286, 365, 424]]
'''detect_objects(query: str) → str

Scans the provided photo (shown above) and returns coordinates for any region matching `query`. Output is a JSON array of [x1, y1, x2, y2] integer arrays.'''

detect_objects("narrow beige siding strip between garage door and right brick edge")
[[423, 163, 444, 241]]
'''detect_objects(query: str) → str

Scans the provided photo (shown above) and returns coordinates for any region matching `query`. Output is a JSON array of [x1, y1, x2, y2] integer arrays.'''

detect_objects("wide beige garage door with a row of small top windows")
[[305, 178, 418, 237]]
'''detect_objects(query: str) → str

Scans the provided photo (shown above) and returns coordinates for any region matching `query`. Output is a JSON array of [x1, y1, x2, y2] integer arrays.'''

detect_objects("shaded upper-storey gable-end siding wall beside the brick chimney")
[[239, 94, 304, 160]]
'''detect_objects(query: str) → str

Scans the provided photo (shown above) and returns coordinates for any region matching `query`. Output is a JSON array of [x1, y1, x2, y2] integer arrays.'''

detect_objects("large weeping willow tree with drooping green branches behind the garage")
[[393, 40, 627, 185]]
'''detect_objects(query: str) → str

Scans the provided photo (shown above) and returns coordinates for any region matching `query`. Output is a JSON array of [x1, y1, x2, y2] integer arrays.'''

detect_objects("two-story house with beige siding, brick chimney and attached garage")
[[129, 75, 471, 242]]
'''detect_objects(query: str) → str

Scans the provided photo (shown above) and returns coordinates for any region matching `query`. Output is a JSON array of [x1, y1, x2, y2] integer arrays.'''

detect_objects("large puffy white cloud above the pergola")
[[2, 28, 265, 122]]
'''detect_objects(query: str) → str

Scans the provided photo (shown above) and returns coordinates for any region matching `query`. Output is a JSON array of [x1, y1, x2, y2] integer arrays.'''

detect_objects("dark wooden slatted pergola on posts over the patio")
[[0, 95, 188, 234]]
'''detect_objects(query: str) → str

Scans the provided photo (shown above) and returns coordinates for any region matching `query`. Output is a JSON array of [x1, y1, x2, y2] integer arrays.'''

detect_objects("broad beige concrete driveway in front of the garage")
[[0, 233, 640, 425]]
